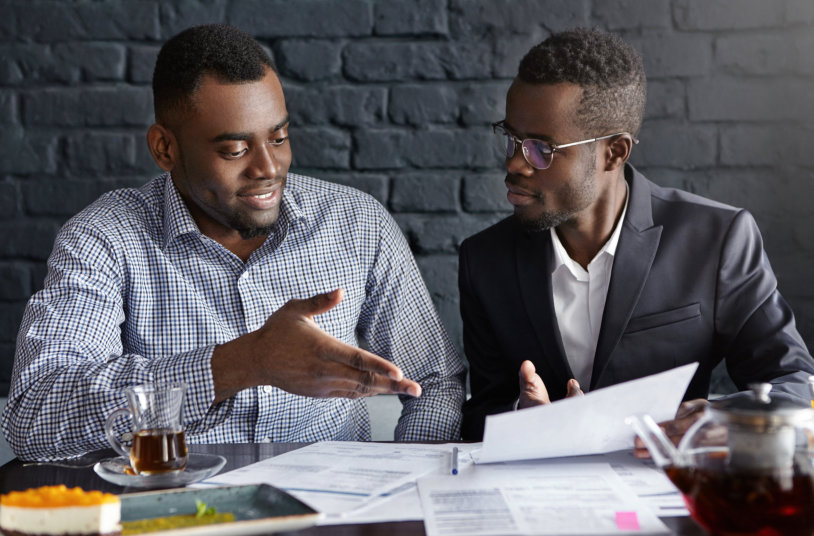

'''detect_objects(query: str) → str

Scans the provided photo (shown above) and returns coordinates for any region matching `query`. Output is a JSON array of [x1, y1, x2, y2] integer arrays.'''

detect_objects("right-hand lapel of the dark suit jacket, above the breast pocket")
[[591, 165, 662, 389]]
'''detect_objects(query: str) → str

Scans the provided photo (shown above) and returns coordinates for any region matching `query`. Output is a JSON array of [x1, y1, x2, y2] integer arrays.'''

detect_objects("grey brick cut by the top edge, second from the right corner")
[[673, 0, 784, 30]]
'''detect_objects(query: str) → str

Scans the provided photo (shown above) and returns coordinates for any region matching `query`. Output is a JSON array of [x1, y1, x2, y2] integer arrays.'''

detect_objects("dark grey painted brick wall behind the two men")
[[0, 0, 814, 393]]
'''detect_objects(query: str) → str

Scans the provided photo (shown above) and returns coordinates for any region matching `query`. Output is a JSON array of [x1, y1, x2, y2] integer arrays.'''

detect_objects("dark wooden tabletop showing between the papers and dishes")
[[0, 443, 707, 536]]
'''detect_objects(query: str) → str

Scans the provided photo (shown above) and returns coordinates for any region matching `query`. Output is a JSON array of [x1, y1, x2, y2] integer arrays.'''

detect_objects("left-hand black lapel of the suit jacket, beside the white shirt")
[[516, 227, 572, 390]]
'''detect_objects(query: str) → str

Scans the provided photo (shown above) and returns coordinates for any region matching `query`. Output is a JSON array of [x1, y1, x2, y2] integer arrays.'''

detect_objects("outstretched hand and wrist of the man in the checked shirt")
[[212, 289, 421, 403]]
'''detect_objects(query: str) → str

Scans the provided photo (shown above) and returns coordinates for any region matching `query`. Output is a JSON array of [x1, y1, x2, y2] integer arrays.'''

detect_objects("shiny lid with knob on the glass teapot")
[[710, 383, 814, 429]]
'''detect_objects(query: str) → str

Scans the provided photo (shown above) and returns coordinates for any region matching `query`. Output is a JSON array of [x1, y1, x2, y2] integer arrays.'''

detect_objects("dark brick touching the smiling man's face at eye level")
[[290, 126, 351, 169]]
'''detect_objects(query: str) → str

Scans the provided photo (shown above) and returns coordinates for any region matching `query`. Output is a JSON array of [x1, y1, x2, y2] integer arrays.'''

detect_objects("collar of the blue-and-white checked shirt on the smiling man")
[[162, 173, 308, 253]]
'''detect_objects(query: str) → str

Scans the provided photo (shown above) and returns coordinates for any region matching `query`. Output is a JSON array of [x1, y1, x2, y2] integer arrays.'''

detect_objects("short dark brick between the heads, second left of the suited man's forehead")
[[389, 84, 458, 126]]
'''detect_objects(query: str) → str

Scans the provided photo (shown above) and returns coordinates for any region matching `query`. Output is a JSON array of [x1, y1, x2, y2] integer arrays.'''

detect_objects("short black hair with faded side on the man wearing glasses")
[[517, 28, 647, 136]]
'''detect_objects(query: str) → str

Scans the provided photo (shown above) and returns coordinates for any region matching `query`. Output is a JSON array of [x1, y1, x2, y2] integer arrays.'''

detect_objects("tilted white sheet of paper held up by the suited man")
[[475, 363, 698, 463]]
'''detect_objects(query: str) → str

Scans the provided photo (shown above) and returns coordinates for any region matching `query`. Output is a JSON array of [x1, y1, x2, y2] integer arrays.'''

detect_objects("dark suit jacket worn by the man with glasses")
[[458, 165, 814, 440]]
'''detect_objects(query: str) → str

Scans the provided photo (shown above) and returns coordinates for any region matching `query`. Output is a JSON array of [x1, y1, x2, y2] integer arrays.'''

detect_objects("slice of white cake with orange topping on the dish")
[[0, 486, 122, 536]]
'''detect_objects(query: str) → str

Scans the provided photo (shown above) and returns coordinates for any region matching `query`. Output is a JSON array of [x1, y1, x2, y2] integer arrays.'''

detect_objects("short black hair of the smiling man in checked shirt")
[[153, 24, 277, 123]]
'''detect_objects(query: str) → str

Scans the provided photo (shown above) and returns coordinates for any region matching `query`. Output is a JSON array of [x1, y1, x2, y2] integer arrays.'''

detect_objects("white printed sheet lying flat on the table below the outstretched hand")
[[194, 441, 480, 524]]
